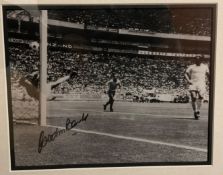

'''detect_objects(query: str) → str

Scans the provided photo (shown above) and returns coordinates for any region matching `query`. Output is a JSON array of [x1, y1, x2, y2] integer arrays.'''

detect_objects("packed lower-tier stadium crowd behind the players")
[[9, 46, 209, 99]]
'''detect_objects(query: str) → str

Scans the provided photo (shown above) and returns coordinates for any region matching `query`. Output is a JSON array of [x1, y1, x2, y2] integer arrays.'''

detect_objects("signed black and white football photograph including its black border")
[[3, 4, 216, 170]]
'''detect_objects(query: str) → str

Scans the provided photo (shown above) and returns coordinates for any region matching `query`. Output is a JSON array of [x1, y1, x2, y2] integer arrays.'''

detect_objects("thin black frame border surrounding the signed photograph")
[[3, 4, 217, 170]]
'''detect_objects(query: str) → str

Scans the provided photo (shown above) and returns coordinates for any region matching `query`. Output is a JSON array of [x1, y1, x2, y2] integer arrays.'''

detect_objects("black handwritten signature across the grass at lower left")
[[38, 113, 88, 153]]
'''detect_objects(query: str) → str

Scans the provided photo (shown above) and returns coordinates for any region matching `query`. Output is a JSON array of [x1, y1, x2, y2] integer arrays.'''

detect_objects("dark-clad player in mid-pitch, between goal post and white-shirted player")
[[103, 75, 121, 112]]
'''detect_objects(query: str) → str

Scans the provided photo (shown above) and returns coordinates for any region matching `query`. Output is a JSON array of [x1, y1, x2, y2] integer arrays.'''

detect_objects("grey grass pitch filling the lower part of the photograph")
[[14, 101, 208, 168]]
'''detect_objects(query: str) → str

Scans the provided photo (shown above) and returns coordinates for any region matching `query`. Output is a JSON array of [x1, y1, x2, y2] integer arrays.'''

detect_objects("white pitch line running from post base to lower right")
[[46, 125, 207, 153]]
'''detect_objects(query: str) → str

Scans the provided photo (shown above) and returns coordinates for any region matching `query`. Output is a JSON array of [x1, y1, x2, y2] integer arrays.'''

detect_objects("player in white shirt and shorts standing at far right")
[[185, 55, 209, 120]]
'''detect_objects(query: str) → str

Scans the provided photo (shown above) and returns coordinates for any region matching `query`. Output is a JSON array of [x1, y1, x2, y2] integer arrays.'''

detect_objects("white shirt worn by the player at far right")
[[186, 63, 209, 83]]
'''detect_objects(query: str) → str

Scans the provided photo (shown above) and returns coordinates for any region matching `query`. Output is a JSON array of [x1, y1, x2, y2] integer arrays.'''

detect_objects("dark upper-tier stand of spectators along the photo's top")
[[8, 8, 211, 36]]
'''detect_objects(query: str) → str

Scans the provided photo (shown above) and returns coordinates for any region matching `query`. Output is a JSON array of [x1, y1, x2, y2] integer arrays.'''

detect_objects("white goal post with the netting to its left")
[[8, 10, 47, 125]]
